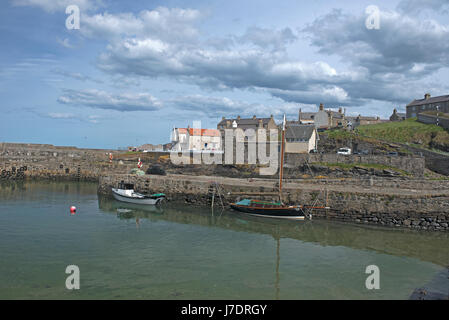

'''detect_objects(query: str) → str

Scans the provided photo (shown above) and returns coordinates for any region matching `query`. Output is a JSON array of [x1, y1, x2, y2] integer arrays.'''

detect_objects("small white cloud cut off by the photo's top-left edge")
[[12, 0, 104, 13]]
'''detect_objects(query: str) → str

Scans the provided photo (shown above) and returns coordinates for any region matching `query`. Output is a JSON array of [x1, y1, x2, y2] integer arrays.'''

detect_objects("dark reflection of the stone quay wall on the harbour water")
[[98, 197, 449, 267]]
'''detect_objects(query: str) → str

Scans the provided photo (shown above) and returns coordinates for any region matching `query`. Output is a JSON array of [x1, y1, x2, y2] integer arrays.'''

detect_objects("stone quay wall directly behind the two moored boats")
[[98, 175, 449, 231]]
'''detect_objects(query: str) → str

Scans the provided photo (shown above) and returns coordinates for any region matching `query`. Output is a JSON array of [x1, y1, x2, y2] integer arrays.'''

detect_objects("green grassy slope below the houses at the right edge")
[[356, 118, 449, 149]]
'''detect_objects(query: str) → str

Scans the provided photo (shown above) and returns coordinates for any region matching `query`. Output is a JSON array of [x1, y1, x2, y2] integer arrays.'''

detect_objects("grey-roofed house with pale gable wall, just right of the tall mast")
[[285, 124, 319, 153]]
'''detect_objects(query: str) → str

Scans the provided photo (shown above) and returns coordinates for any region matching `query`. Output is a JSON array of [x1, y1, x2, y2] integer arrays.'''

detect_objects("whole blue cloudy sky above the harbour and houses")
[[0, 0, 449, 149]]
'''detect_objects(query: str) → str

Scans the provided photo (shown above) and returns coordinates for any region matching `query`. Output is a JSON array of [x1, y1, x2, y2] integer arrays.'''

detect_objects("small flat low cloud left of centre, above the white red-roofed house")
[[58, 89, 162, 112]]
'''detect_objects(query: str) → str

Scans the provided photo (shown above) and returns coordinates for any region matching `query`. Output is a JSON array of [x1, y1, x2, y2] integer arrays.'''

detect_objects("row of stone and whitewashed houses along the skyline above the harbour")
[[135, 94, 449, 153]]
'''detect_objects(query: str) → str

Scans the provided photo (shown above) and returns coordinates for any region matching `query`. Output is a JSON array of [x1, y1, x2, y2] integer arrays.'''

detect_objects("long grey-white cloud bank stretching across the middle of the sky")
[[98, 31, 357, 99]]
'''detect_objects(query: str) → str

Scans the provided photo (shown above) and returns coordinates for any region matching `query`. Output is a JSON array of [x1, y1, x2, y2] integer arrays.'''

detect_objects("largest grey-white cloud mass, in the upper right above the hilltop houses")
[[302, 10, 449, 103]]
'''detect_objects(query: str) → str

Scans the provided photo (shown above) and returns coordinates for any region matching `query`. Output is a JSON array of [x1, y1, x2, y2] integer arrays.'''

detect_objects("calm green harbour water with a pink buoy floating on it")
[[0, 181, 449, 299]]
